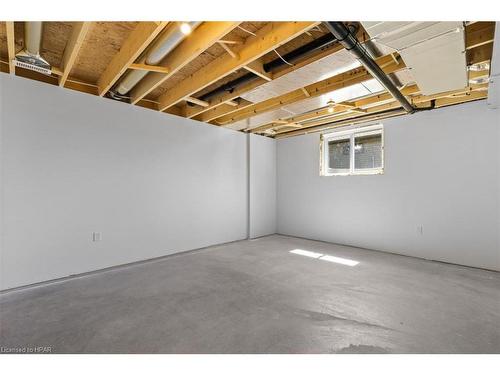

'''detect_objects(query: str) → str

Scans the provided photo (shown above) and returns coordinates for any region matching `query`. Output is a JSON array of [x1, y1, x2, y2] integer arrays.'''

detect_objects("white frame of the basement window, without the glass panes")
[[320, 124, 384, 176]]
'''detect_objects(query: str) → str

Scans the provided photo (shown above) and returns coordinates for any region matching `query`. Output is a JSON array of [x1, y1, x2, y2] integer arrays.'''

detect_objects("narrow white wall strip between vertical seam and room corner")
[[249, 134, 276, 238]]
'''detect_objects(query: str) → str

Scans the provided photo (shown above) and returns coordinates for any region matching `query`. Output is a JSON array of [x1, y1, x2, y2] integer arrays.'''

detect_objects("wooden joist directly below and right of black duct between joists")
[[184, 28, 368, 118]]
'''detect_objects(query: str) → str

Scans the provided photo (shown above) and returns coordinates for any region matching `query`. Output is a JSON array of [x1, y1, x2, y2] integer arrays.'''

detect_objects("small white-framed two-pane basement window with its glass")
[[320, 124, 384, 176]]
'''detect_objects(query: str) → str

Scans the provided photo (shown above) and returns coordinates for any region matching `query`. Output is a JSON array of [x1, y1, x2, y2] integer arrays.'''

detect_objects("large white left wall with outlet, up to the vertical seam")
[[0, 74, 248, 289]]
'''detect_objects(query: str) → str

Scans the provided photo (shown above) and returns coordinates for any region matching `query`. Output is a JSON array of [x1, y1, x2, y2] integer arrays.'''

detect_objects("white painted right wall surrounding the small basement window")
[[277, 101, 500, 270]]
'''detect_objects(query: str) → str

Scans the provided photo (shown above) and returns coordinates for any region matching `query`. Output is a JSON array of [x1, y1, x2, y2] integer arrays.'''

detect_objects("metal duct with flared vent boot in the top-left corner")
[[14, 22, 52, 75]]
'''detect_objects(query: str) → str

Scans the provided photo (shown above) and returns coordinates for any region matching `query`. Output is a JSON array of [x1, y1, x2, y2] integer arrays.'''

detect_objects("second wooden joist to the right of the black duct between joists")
[[217, 55, 406, 125]]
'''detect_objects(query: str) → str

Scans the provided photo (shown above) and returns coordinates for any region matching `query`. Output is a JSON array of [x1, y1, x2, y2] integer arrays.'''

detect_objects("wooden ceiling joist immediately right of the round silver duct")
[[130, 22, 239, 104]]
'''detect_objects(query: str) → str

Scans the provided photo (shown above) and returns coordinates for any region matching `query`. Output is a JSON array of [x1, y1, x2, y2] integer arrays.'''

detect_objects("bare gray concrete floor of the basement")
[[0, 235, 500, 353]]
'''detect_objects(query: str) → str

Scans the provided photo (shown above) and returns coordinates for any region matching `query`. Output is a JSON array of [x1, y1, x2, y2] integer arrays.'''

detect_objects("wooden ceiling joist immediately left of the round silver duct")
[[97, 21, 168, 96]]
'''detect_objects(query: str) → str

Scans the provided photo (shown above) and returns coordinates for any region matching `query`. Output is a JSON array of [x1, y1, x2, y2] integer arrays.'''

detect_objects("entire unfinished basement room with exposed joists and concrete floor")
[[0, 2, 500, 374]]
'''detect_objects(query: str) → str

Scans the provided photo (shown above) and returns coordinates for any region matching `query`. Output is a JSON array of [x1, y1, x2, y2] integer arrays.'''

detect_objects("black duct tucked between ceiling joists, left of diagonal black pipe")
[[198, 31, 344, 101]]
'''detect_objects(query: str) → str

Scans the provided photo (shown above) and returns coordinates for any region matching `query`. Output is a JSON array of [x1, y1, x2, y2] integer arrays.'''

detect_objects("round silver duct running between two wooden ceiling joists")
[[110, 21, 201, 98]]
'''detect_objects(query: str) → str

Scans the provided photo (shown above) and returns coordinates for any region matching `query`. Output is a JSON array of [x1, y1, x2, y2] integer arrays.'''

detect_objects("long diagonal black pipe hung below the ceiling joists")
[[325, 21, 415, 113]]
